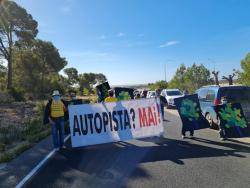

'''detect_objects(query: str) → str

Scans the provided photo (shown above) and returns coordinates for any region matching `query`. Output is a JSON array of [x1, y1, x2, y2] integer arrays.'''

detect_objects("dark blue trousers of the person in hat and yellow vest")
[[51, 117, 64, 148]]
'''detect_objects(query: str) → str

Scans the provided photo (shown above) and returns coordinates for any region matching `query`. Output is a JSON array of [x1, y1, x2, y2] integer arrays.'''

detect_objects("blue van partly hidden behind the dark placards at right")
[[196, 85, 250, 129]]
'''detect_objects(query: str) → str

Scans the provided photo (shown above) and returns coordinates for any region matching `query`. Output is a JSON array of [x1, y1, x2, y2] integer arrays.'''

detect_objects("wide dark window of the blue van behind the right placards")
[[220, 88, 250, 102]]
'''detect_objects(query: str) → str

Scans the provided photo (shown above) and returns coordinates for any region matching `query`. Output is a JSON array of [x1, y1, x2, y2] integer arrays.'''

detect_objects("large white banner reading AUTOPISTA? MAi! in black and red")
[[69, 98, 163, 147]]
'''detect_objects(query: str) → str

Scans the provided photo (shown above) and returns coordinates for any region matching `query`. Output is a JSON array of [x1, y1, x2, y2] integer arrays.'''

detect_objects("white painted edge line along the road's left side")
[[16, 135, 70, 188]]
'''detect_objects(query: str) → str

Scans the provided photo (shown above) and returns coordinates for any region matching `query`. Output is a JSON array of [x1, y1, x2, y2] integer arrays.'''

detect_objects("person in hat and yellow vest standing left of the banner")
[[44, 90, 66, 151]]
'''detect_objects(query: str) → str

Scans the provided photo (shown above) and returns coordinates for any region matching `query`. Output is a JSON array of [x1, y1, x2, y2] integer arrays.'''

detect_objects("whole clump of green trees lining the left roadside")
[[0, 0, 107, 101]]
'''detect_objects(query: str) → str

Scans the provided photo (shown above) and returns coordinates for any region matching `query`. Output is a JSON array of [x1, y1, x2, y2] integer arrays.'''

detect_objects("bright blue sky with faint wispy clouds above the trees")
[[17, 0, 250, 85]]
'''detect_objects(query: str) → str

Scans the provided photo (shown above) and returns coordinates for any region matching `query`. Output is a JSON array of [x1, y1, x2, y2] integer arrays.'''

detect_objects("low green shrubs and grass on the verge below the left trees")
[[0, 103, 51, 163]]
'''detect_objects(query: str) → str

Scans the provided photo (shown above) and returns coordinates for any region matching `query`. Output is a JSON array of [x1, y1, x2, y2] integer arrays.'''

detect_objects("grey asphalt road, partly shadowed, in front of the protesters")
[[23, 110, 250, 188]]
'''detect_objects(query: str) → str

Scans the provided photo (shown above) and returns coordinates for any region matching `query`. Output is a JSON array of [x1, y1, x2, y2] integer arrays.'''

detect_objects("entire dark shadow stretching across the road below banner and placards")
[[27, 138, 250, 187]]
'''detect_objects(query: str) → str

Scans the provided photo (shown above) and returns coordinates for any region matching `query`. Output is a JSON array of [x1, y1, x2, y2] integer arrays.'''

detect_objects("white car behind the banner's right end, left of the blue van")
[[161, 89, 184, 108]]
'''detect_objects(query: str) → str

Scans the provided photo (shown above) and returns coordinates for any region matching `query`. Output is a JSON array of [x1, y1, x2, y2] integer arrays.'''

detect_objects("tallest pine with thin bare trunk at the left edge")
[[0, 1, 38, 89]]
